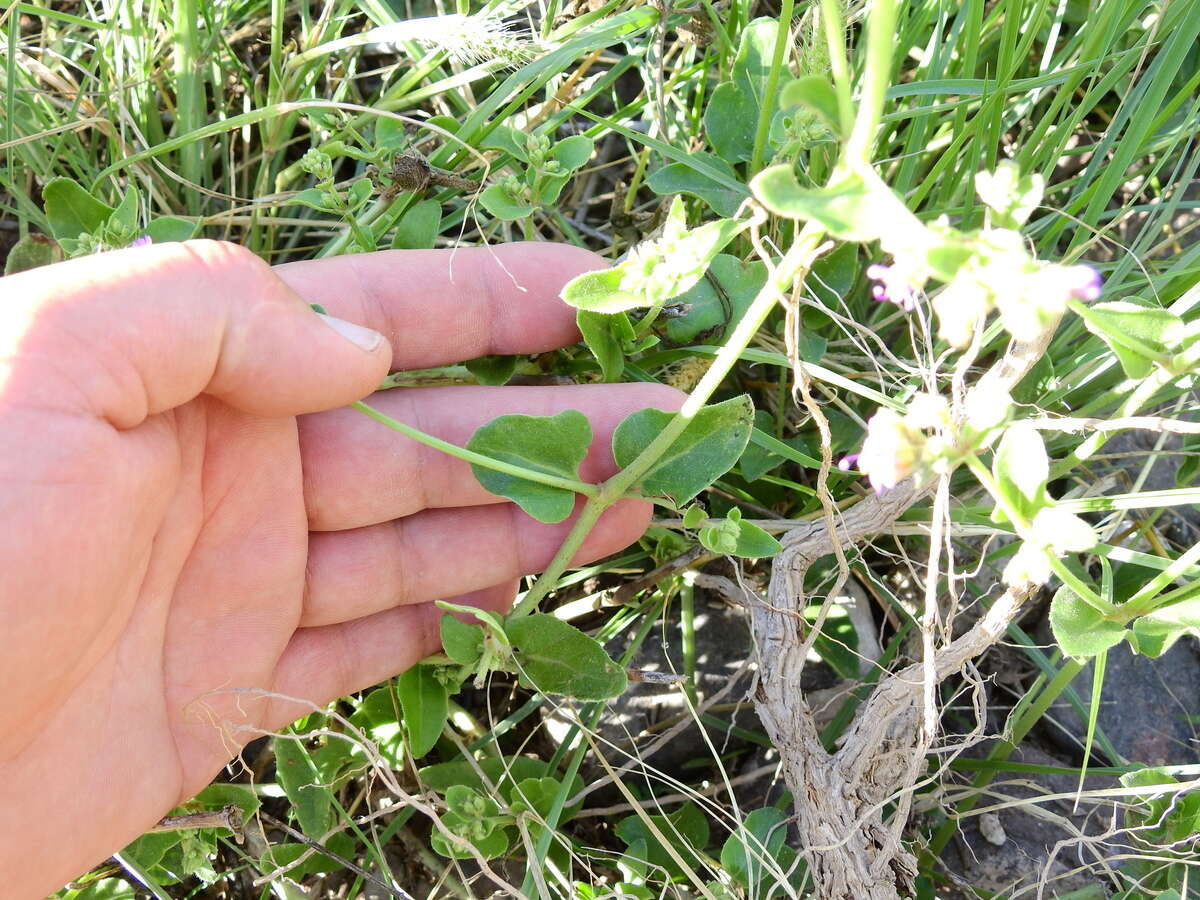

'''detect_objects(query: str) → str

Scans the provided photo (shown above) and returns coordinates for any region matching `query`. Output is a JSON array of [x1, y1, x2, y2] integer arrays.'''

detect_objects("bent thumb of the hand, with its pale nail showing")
[[0, 241, 391, 428]]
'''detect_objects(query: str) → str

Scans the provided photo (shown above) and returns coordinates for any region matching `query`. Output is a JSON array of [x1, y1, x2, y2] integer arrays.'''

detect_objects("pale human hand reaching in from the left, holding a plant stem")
[[0, 241, 682, 900]]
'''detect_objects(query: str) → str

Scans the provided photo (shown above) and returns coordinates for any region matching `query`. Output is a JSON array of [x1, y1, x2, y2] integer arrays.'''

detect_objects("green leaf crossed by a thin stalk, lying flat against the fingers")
[[467, 409, 592, 522]]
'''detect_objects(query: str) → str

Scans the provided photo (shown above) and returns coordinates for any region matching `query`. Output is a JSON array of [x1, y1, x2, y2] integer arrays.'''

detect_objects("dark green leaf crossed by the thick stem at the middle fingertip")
[[612, 395, 754, 506]]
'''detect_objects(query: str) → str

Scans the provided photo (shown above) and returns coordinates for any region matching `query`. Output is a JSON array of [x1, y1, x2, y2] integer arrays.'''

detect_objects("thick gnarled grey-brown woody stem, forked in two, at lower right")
[[750, 322, 1057, 900]]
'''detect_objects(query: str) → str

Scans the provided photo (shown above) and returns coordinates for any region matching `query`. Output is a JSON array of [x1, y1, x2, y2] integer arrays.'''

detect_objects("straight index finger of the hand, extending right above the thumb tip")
[[275, 242, 607, 368]]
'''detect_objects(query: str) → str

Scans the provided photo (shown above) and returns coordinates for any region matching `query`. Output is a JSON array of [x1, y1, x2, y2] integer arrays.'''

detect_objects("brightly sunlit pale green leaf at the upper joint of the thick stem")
[[750, 169, 908, 241]]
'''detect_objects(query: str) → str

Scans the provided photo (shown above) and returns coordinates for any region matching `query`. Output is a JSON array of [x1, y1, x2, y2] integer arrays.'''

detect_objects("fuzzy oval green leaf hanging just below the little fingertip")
[[505, 612, 626, 700]]
